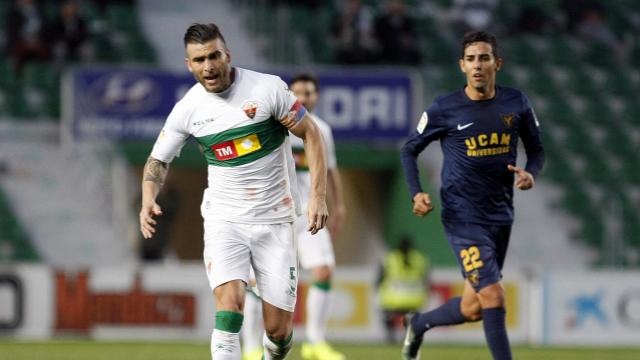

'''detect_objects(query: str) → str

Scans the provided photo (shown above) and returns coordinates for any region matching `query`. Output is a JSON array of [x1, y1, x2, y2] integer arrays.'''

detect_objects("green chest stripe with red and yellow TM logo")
[[196, 118, 287, 167]]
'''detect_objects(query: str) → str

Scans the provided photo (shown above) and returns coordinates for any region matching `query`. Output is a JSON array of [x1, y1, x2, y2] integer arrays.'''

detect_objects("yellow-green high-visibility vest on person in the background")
[[380, 250, 427, 311]]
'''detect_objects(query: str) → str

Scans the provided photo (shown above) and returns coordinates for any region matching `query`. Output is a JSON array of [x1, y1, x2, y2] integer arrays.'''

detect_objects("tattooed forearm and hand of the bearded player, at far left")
[[140, 156, 169, 239]]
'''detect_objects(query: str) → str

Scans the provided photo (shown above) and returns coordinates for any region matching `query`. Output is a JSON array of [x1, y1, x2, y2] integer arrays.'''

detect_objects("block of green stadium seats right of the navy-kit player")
[[499, 36, 640, 267]]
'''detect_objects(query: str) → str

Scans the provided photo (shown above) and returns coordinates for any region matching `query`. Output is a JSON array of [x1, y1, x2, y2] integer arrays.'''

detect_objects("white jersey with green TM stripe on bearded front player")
[[151, 68, 301, 224]]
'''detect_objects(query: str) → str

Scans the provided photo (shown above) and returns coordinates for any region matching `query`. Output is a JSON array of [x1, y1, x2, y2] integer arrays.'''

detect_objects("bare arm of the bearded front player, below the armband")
[[282, 115, 329, 234]]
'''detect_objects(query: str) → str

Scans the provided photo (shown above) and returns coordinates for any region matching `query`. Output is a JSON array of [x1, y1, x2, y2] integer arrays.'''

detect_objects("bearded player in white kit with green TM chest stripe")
[[140, 24, 328, 360]]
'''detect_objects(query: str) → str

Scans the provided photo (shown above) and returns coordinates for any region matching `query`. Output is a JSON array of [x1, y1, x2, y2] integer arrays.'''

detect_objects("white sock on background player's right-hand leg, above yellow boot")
[[305, 286, 331, 344]]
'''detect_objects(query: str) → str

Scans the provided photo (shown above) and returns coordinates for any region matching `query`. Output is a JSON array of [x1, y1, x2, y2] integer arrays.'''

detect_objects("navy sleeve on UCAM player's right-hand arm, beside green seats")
[[520, 94, 545, 178]]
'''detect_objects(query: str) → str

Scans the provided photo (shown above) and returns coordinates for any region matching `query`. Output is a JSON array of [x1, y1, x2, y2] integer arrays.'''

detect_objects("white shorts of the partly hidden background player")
[[296, 216, 336, 269]]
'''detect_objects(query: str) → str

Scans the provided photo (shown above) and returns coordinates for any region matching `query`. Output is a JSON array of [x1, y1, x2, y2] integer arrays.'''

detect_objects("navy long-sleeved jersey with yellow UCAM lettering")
[[401, 86, 544, 224]]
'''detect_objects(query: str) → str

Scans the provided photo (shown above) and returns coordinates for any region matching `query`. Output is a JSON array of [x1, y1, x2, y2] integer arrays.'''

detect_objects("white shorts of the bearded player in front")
[[203, 221, 298, 312]]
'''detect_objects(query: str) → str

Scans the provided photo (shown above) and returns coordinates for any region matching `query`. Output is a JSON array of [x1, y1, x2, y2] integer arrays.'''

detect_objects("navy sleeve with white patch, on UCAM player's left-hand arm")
[[400, 103, 446, 199]]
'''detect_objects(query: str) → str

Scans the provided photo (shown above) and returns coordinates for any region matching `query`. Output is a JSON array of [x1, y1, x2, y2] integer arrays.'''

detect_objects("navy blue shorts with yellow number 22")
[[443, 221, 511, 292]]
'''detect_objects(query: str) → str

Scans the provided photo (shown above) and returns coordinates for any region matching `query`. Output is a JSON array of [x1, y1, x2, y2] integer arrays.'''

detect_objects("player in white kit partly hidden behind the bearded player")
[[243, 74, 346, 360]]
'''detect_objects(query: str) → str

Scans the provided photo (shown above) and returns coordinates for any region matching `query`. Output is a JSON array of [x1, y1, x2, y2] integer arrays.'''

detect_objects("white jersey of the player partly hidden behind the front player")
[[290, 113, 337, 207]]
